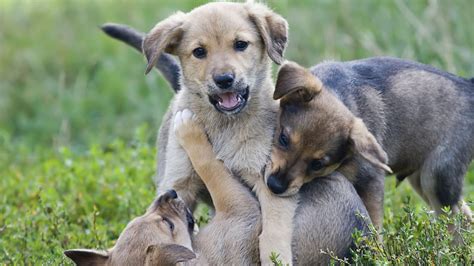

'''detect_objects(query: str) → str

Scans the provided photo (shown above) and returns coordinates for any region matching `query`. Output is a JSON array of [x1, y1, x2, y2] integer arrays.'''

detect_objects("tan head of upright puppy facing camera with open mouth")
[[143, 2, 288, 114]]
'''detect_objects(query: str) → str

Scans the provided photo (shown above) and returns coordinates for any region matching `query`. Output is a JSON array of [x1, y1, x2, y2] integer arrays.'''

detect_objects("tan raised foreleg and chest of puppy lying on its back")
[[174, 110, 262, 265]]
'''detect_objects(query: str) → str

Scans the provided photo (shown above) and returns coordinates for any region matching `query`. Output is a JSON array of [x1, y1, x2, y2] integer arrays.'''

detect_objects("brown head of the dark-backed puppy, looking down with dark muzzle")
[[265, 63, 390, 196]]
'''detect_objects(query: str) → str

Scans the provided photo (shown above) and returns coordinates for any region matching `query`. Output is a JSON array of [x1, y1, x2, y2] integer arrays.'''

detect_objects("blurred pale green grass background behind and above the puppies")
[[0, 0, 474, 148]]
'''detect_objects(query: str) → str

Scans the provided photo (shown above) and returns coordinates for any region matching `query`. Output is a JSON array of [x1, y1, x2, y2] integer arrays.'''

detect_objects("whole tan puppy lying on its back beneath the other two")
[[65, 110, 367, 265]]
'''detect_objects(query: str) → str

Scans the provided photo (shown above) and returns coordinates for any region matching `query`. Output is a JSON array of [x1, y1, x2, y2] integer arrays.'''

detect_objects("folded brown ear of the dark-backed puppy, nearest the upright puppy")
[[273, 62, 323, 102]]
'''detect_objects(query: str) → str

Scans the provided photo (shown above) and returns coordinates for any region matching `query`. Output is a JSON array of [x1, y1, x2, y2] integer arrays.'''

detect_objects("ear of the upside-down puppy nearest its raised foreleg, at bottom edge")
[[145, 244, 196, 266]]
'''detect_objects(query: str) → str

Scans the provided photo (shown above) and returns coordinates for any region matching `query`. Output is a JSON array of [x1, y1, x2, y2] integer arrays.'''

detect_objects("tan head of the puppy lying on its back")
[[64, 190, 196, 265]]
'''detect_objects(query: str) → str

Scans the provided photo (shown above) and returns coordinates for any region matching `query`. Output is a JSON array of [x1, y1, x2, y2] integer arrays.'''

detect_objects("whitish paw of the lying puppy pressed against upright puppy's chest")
[[173, 109, 205, 145]]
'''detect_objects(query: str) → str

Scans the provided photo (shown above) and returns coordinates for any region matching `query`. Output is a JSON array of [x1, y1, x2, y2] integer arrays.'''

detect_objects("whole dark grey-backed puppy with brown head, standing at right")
[[266, 58, 474, 227]]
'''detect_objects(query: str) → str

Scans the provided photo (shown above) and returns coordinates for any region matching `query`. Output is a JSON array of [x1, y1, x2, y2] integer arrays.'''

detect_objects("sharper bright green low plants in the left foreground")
[[0, 130, 155, 265]]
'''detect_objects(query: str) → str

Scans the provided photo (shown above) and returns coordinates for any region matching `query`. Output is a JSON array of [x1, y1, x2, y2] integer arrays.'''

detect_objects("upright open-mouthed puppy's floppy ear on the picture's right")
[[246, 3, 288, 65]]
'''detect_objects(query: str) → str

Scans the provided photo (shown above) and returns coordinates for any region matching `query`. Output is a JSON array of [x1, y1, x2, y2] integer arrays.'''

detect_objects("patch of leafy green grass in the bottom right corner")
[[353, 204, 474, 265]]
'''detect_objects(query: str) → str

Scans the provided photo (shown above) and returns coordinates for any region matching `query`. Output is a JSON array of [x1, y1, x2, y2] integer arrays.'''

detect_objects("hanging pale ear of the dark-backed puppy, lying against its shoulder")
[[349, 118, 392, 173]]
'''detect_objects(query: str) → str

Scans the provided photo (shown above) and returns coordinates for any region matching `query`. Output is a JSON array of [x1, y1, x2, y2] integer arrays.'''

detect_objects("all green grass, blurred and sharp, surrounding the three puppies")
[[0, 0, 474, 264]]
